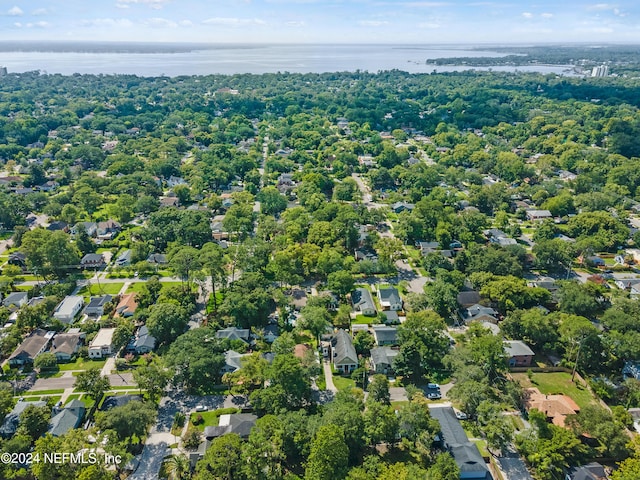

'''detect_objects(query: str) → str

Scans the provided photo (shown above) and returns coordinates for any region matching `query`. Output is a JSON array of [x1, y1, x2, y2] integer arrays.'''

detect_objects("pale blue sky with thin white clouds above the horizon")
[[0, 0, 640, 44]]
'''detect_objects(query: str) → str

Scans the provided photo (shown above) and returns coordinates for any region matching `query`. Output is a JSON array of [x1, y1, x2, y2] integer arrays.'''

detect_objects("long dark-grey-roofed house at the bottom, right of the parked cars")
[[429, 405, 493, 480]]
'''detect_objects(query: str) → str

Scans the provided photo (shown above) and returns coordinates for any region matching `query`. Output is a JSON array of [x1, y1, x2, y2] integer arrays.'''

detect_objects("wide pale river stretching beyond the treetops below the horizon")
[[0, 45, 568, 77]]
